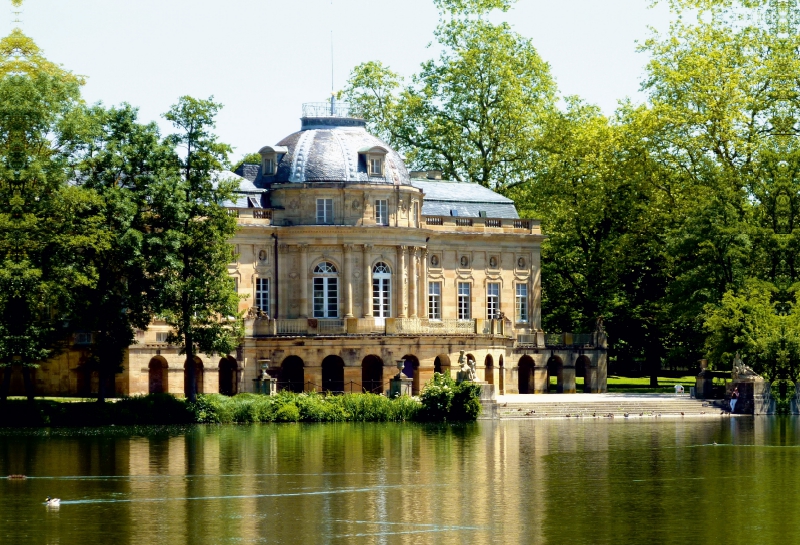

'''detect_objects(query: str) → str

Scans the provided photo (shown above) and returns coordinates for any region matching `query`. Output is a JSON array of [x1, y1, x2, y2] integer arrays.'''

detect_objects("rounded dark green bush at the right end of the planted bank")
[[418, 373, 481, 422]]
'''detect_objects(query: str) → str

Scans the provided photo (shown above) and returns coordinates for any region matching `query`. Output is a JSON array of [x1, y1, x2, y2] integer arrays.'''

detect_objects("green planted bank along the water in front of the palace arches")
[[0, 375, 481, 427]]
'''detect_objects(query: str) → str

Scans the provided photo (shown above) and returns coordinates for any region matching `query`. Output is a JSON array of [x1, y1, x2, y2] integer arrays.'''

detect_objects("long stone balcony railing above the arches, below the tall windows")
[[245, 318, 511, 337]]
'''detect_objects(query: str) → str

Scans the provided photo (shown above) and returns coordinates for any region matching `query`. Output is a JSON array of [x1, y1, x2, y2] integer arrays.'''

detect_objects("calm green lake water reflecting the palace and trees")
[[0, 418, 800, 545]]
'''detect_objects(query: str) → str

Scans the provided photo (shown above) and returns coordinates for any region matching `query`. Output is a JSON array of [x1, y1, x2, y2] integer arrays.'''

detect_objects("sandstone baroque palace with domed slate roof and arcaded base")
[[20, 102, 606, 395]]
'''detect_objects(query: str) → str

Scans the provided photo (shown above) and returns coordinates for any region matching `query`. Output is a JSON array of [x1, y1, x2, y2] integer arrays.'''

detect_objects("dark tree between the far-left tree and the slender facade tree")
[[71, 105, 172, 403]]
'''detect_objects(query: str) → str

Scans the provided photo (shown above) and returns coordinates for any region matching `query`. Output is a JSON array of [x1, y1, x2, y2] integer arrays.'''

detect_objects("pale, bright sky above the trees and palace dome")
[[15, 0, 670, 159]]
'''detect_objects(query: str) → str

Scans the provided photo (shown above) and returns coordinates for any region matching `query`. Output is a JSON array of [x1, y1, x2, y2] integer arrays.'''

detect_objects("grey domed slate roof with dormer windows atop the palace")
[[262, 111, 411, 185]]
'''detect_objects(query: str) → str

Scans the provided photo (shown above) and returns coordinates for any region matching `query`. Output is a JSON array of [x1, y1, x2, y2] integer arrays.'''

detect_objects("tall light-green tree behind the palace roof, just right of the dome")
[[343, 1, 555, 190]]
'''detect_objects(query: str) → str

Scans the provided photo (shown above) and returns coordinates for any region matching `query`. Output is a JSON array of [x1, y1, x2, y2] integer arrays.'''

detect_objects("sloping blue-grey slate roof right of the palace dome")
[[411, 178, 519, 219]]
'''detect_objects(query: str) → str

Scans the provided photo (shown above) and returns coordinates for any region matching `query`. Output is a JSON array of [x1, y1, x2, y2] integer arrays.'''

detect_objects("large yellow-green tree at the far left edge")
[[0, 29, 109, 399]]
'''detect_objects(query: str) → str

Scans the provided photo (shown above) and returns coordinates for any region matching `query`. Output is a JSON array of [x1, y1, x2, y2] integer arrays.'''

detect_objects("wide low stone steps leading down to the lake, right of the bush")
[[497, 396, 727, 418]]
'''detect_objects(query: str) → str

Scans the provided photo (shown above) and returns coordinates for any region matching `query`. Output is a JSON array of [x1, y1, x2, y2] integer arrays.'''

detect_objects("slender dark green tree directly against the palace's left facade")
[[145, 96, 243, 401]]
